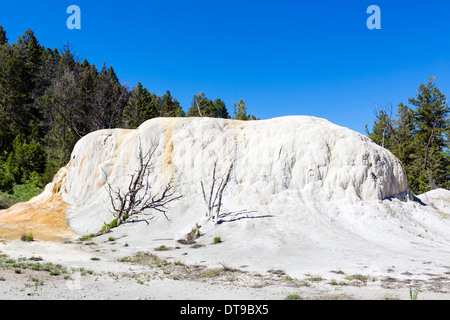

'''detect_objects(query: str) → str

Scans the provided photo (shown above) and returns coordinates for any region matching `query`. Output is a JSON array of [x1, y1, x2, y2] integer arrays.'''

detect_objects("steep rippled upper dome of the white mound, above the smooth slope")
[[38, 116, 409, 232]]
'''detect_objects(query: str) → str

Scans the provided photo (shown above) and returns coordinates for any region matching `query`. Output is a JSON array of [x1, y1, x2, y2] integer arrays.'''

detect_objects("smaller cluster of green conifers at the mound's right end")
[[366, 78, 450, 194]]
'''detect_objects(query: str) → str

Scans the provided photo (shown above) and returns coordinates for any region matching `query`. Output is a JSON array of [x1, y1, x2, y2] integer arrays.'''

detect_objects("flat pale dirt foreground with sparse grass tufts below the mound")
[[0, 236, 450, 300]]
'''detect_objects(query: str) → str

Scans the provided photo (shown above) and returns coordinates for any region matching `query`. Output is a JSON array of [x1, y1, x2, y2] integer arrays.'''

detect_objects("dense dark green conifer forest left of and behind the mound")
[[0, 26, 256, 192]]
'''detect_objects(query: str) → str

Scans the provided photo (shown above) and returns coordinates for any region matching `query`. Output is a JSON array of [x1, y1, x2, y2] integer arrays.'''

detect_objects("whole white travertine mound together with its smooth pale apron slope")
[[8, 116, 450, 275]]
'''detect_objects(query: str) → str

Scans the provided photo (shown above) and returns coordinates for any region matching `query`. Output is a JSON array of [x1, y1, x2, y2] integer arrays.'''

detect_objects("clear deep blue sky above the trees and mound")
[[0, 0, 450, 132]]
